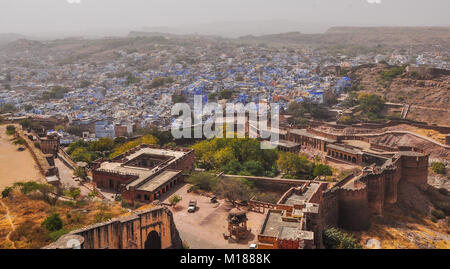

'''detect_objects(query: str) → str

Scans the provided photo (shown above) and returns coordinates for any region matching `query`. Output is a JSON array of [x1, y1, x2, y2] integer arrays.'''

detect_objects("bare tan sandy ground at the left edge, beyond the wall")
[[0, 125, 43, 191]]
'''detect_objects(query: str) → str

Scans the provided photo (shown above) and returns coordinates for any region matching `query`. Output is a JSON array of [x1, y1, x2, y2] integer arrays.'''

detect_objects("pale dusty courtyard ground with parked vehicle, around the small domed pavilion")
[[161, 184, 265, 249]]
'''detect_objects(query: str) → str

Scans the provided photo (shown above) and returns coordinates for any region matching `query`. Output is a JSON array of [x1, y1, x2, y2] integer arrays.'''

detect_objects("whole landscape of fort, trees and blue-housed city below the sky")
[[0, 1, 450, 255]]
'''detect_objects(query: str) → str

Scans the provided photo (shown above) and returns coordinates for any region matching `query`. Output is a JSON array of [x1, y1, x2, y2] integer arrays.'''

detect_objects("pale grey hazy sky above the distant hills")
[[0, 0, 450, 35]]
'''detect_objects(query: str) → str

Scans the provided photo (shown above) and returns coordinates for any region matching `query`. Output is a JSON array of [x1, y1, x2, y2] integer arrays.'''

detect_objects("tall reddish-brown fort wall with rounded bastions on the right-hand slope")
[[322, 151, 428, 230]]
